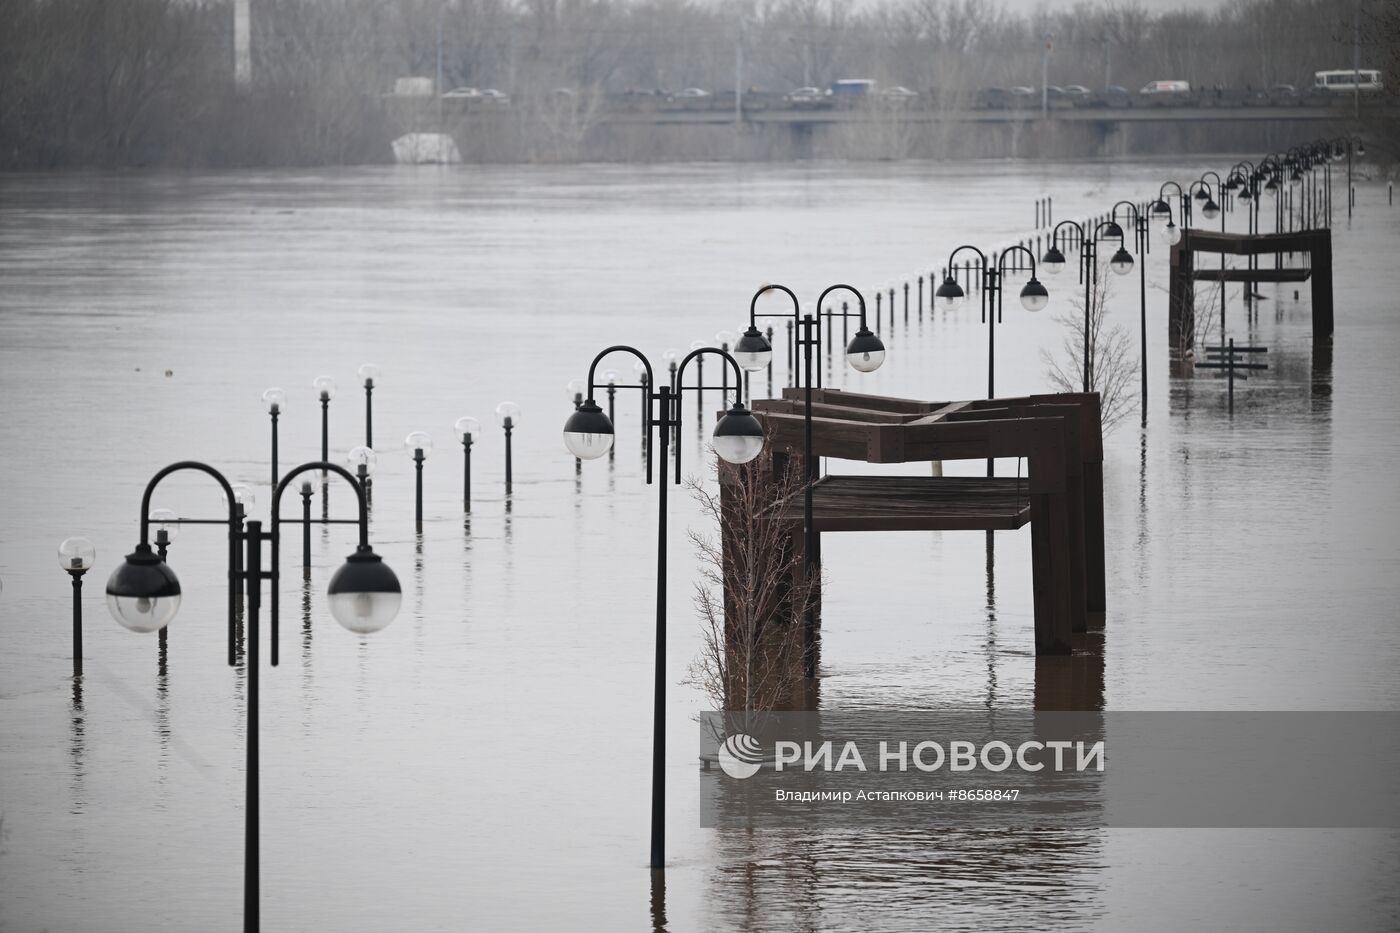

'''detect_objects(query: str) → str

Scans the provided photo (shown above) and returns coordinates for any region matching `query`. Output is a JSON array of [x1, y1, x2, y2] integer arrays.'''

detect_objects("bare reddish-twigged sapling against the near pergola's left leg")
[[687, 454, 820, 716]]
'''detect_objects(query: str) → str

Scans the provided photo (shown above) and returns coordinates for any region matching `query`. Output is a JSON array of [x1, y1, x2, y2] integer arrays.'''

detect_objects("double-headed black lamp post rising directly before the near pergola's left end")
[[734, 284, 885, 678]]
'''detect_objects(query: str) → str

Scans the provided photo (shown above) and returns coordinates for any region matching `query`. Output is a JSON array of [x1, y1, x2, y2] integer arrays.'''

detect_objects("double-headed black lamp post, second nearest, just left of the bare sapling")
[[564, 345, 763, 869]]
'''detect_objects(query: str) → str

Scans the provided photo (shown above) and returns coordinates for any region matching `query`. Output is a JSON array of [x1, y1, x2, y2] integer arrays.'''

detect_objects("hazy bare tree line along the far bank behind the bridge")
[[0, 0, 1400, 170]]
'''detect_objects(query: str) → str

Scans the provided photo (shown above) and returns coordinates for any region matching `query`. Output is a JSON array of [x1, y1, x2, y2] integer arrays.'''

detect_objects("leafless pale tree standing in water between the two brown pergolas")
[[1040, 254, 1138, 431]]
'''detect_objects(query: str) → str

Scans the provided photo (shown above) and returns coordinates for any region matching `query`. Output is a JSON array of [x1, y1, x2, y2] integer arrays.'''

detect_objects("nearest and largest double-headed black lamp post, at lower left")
[[106, 461, 403, 933]]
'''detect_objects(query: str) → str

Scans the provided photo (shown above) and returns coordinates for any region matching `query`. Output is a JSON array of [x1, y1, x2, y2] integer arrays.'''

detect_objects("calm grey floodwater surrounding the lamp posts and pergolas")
[[0, 163, 1400, 932]]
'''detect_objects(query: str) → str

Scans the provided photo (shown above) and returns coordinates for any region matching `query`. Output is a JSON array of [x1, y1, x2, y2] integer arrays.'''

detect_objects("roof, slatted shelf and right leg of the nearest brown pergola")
[[721, 388, 1105, 654]]
